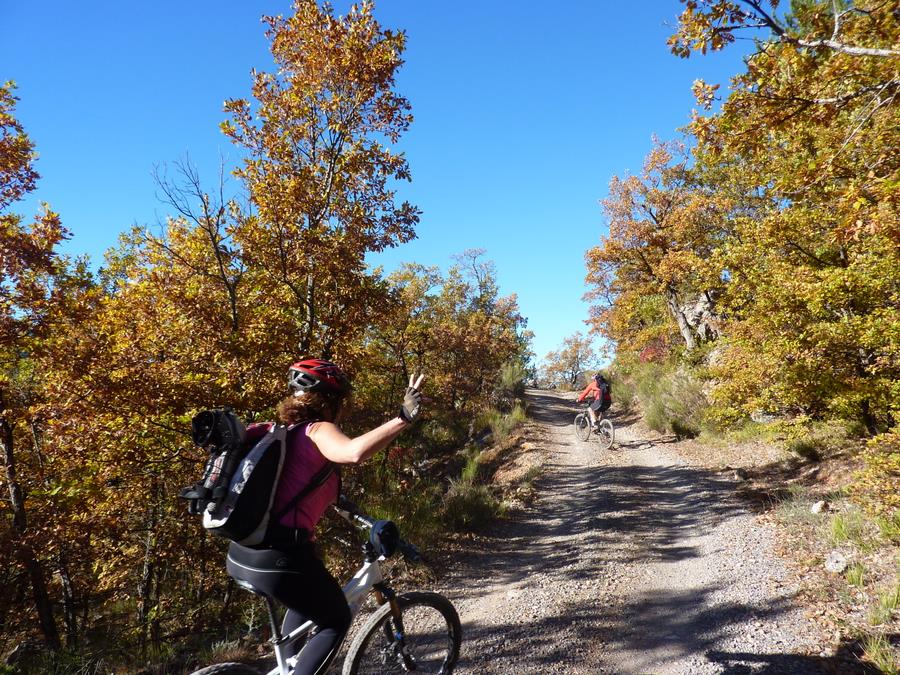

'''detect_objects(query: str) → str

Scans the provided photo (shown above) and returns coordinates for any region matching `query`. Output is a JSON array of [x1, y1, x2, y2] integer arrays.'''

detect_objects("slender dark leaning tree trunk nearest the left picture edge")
[[0, 419, 60, 651]]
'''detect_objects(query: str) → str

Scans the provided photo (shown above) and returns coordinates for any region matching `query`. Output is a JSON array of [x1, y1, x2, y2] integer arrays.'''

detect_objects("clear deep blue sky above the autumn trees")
[[0, 0, 742, 364]]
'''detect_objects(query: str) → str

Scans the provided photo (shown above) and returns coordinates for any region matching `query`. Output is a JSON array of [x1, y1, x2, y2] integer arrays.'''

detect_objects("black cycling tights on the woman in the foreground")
[[227, 543, 352, 675]]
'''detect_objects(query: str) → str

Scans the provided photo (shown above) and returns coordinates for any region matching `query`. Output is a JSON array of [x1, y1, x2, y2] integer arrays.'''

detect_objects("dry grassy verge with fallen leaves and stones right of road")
[[660, 420, 900, 673]]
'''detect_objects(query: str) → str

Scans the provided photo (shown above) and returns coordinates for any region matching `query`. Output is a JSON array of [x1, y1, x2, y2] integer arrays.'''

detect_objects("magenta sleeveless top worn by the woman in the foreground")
[[272, 424, 341, 534]]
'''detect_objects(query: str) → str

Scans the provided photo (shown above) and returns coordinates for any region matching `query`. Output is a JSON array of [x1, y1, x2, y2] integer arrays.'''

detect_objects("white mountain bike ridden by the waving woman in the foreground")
[[193, 498, 462, 675]]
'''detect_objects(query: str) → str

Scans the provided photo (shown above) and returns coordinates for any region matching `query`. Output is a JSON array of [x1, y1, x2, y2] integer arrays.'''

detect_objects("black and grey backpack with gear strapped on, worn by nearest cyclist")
[[180, 408, 334, 546]]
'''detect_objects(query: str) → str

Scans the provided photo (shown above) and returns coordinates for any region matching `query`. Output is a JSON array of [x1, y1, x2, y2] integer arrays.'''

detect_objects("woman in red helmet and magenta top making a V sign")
[[226, 359, 424, 675]]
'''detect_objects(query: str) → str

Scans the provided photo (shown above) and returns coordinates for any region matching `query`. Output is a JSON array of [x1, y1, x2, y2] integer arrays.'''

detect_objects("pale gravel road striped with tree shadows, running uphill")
[[440, 390, 853, 675]]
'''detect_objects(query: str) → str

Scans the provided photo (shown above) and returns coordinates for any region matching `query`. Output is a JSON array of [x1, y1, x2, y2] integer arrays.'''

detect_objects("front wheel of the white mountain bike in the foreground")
[[343, 593, 462, 675]]
